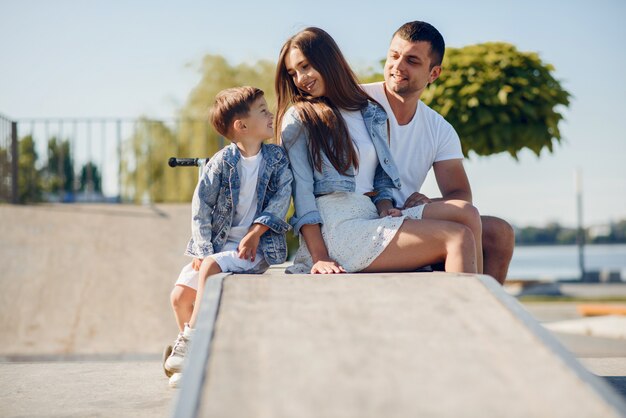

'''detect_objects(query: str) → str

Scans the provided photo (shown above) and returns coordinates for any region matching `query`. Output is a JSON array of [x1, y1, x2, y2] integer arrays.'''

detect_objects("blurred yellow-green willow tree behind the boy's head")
[[122, 55, 276, 202]]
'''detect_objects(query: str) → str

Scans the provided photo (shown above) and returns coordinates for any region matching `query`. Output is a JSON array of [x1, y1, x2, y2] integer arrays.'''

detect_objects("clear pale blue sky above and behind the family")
[[0, 0, 626, 226]]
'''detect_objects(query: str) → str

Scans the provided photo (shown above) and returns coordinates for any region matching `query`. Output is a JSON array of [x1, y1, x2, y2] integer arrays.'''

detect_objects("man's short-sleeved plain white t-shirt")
[[361, 82, 463, 206]]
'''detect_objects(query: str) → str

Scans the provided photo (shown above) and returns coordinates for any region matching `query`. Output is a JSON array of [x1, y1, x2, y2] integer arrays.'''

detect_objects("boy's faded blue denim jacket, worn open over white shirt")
[[185, 144, 293, 265]]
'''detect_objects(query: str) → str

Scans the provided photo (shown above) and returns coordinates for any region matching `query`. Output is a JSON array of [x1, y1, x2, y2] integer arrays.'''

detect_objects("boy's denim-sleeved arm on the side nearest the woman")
[[254, 155, 293, 234]]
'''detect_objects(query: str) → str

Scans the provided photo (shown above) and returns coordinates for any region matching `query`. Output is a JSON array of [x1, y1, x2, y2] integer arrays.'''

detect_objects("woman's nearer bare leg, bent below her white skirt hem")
[[362, 219, 476, 273]]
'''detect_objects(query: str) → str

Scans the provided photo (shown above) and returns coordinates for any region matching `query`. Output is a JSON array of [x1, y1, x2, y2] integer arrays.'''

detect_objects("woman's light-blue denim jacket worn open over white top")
[[281, 101, 400, 233]]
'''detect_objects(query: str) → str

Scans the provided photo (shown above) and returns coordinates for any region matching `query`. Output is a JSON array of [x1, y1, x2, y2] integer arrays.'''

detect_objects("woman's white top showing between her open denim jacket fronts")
[[340, 109, 378, 193]]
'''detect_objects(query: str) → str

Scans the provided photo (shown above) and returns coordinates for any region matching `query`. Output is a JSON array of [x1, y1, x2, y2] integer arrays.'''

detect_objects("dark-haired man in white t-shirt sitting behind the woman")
[[362, 21, 515, 284]]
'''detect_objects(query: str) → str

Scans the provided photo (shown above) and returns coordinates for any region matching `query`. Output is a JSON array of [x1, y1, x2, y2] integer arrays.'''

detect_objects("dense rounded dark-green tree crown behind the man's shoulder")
[[422, 42, 570, 158]]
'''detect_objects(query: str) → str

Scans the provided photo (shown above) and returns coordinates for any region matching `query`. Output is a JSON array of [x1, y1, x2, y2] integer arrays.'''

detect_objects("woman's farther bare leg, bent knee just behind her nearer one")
[[422, 200, 483, 273]]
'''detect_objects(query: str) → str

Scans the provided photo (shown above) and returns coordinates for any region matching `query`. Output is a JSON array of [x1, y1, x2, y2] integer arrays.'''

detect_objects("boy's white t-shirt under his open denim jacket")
[[228, 151, 263, 242]]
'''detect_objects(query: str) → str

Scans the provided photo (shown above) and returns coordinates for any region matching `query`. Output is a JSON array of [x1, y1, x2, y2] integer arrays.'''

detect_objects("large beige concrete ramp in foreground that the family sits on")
[[173, 271, 626, 418]]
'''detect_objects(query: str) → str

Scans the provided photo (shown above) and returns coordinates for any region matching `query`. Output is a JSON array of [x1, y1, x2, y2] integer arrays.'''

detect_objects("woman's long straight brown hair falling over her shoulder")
[[274, 27, 369, 174]]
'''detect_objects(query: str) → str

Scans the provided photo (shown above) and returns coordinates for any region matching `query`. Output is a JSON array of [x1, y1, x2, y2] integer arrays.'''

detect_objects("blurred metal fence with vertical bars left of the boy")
[[0, 115, 224, 203]]
